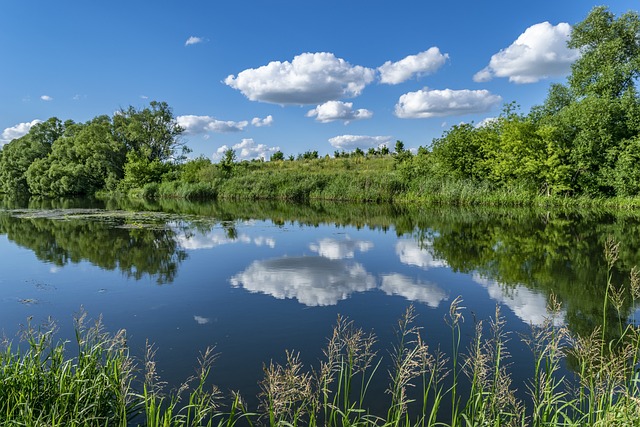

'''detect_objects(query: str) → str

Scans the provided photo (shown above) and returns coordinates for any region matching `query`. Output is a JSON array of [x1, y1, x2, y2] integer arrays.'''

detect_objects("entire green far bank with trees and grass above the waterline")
[[0, 7, 640, 203]]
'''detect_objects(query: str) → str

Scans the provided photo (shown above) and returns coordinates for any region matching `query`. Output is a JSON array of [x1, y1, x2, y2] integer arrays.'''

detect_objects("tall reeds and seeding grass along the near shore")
[[0, 240, 640, 427]]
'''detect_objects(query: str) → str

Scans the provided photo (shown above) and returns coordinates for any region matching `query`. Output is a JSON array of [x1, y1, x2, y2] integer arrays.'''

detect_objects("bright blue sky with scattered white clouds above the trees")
[[0, 0, 638, 160]]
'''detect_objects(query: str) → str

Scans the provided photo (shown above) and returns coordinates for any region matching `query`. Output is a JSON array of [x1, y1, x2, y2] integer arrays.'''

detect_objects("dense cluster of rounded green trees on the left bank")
[[0, 101, 186, 196]]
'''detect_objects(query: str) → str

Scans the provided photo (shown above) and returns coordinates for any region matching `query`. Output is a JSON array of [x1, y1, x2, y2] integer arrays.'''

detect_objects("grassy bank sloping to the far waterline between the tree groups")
[[114, 155, 640, 209]]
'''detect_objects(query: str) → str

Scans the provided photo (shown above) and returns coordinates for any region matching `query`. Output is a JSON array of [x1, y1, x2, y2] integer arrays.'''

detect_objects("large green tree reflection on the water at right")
[[415, 211, 640, 342]]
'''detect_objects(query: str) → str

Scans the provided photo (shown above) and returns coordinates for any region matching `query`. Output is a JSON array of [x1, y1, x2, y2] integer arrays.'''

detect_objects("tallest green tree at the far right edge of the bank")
[[540, 7, 640, 196]]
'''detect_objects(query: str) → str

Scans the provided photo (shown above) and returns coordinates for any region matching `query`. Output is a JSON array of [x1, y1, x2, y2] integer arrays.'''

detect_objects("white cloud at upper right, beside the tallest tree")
[[473, 22, 580, 83]]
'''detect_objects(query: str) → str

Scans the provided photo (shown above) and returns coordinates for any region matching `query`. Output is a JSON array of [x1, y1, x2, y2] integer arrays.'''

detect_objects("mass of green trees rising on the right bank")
[[424, 7, 640, 197]]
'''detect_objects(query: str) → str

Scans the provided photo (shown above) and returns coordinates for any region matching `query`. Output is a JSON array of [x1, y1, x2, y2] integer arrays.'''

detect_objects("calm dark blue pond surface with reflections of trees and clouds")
[[0, 200, 640, 418]]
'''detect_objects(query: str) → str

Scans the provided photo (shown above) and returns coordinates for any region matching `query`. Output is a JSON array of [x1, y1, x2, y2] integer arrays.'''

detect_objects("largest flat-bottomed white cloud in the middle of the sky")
[[224, 52, 375, 105]]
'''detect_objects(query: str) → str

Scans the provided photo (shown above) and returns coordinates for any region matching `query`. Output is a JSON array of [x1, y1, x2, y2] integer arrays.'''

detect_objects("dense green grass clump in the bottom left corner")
[[0, 315, 134, 427]]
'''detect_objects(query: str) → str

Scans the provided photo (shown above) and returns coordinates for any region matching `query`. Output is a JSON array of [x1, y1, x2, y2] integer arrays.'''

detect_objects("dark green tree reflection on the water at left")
[[0, 214, 187, 284]]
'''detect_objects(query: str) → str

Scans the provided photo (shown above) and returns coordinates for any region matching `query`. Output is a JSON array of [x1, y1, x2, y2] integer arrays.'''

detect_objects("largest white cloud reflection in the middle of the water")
[[230, 256, 376, 307]]
